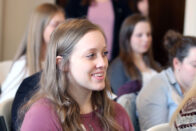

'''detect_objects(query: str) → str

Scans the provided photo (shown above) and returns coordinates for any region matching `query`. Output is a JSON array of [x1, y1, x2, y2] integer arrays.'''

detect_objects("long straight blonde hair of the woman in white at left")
[[14, 3, 64, 75]]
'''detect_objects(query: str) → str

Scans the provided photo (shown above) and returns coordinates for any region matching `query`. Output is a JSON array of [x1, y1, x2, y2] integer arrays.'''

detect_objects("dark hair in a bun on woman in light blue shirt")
[[163, 30, 196, 67]]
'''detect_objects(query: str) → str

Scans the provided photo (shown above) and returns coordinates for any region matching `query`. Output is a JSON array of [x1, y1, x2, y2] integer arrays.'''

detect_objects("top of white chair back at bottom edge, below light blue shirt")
[[147, 123, 171, 131]]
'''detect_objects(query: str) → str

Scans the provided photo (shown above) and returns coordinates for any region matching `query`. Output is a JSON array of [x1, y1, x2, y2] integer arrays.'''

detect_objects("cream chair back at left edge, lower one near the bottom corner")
[[0, 98, 14, 131]]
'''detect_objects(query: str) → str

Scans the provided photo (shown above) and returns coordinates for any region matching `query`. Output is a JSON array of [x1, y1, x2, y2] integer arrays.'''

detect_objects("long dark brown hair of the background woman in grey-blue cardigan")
[[119, 14, 160, 80]]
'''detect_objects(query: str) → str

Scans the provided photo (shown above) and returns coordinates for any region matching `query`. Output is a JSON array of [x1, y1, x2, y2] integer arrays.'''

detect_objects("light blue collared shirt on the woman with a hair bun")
[[136, 68, 183, 131]]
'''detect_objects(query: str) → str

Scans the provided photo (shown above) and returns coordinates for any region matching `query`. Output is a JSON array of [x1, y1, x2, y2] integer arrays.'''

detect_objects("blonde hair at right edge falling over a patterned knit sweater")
[[170, 77, 196, 127]]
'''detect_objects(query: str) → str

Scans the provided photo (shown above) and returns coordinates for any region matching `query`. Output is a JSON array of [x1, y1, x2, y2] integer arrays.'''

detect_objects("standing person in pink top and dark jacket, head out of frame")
[[65, 0, 132, 61]]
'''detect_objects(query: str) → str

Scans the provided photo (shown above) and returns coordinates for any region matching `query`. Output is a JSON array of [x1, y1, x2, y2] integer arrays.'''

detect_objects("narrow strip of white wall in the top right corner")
[[184, 0, 196, 36]]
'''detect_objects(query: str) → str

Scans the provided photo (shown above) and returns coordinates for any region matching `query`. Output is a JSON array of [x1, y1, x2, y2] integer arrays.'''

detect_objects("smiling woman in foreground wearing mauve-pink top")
[[19, 19, 134, 131]]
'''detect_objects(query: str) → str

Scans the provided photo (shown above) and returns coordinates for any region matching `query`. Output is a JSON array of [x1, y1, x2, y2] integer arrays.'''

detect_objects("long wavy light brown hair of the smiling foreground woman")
[[18, 19, 122, 131]]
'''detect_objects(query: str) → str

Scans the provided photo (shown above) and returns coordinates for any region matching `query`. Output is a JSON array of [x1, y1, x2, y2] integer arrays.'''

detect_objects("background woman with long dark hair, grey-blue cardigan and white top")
[[108, 14, 160, 94]]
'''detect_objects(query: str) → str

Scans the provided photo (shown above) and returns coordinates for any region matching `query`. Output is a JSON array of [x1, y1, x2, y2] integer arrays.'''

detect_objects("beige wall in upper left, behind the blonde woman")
[[0, 0, 55, 60]]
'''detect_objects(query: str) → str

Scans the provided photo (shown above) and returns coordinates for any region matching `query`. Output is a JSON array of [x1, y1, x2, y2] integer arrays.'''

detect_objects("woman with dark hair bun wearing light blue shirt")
[[136, 30, 196, 131]]
